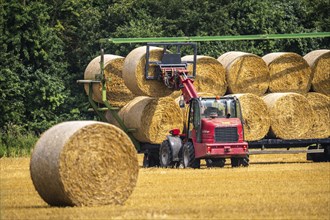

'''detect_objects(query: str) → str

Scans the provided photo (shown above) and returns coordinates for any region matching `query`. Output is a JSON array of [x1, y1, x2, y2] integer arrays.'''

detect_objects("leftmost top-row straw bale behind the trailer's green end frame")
[[84, 54, 135, 107]]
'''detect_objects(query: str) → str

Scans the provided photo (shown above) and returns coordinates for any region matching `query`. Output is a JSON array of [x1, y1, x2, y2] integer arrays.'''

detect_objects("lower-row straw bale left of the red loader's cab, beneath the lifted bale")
[[119, 96, 183, 144]]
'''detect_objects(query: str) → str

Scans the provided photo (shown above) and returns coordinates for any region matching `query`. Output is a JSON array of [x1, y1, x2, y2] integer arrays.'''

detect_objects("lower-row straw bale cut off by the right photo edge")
[[305, 92, 330, 138]]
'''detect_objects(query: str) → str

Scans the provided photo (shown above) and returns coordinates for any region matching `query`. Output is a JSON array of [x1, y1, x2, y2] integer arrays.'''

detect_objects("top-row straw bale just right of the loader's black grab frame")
[[182, 55, 227, 95]]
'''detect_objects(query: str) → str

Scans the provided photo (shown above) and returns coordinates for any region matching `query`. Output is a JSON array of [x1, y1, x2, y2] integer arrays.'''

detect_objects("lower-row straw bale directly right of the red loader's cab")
[[227, 93, 270, 141]]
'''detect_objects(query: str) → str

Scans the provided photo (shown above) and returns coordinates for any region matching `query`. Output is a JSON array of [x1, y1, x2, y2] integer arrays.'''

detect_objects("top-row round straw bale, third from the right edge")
[[218, 51, 269, 95]]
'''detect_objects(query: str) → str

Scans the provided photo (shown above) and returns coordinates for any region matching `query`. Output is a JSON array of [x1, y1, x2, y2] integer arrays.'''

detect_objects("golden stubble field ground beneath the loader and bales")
[[0, 154, 330, 219]]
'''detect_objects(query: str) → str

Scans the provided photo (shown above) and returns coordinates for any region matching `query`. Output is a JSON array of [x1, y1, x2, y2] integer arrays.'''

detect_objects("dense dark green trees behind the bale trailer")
[[0, 0, 330, 153]]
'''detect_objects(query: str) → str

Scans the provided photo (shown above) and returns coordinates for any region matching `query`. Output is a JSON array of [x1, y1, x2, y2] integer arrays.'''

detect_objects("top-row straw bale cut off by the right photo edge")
[[304, 50, 330, 96]]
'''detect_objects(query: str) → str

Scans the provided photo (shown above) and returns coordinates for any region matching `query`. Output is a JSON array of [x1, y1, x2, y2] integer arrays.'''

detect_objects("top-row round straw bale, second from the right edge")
[[262, 52, 312, 93]]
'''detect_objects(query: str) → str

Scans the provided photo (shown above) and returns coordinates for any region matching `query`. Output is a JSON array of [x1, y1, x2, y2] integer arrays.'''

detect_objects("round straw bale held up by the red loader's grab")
[[123, 46, 172, 97]]
